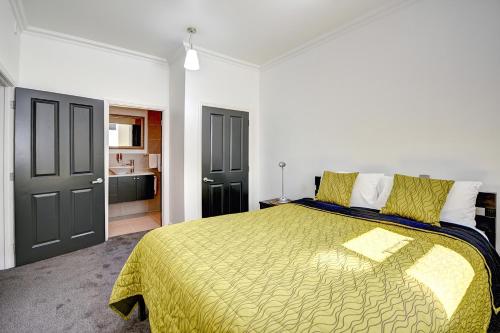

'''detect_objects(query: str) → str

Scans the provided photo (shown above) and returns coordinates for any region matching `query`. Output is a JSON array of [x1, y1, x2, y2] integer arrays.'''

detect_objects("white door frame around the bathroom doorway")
[[104, 99, 170, 241]]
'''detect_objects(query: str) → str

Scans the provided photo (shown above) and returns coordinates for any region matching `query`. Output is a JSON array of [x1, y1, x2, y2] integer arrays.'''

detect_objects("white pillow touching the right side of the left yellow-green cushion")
[[350, 173, 384, 208]]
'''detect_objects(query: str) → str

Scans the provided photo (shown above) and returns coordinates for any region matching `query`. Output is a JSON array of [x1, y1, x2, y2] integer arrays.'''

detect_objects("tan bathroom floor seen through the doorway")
[[108, 212, 161, 238]]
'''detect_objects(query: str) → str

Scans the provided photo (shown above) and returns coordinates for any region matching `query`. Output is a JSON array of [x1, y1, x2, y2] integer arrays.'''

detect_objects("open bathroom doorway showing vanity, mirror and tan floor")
[[108, 106, 163, 237]]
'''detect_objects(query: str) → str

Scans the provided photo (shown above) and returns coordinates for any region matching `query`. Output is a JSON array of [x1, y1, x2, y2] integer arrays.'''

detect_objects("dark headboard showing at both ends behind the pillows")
[[314, 176, 497, 246]]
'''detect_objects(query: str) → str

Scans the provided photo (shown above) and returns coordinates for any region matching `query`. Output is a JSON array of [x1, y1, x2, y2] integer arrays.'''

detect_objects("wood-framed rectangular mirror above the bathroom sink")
[[109, 114, 144, 149]]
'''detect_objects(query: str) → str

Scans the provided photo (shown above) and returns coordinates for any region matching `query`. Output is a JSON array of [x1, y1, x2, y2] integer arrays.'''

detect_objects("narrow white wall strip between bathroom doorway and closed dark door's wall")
[[168, 57, 186, 223]]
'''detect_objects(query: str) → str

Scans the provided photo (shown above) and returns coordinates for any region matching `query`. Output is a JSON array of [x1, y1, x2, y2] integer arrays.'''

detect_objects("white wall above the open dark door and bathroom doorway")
[[19, 32, 169, 108]]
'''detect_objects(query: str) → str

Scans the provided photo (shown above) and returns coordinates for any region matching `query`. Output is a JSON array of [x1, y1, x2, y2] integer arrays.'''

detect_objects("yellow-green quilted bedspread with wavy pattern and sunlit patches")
[[109, 204, 493, 332]]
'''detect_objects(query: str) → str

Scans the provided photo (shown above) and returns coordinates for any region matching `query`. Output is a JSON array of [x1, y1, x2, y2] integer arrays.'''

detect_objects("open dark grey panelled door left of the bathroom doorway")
[[14, 88, 104, 265]]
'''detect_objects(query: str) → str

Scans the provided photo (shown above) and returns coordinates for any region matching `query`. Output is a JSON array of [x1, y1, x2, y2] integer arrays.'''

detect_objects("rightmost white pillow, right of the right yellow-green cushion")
[[440, 181, 482, 227]]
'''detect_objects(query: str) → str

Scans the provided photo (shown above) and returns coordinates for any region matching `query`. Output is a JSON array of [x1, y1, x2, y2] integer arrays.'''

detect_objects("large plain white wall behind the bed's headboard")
[[259, 0, 500, 243]]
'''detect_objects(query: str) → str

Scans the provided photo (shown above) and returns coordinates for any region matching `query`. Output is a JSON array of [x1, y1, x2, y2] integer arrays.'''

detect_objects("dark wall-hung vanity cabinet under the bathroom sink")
[[109, 175, 155, 203]]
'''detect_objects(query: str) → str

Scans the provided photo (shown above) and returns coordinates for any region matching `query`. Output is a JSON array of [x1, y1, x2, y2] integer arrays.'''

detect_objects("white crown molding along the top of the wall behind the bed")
[[260, 0, 419, 71]]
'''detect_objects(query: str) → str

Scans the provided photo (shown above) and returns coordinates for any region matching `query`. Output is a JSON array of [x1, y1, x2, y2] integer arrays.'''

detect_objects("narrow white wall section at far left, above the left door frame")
[[0, 0, 20, 84]]
